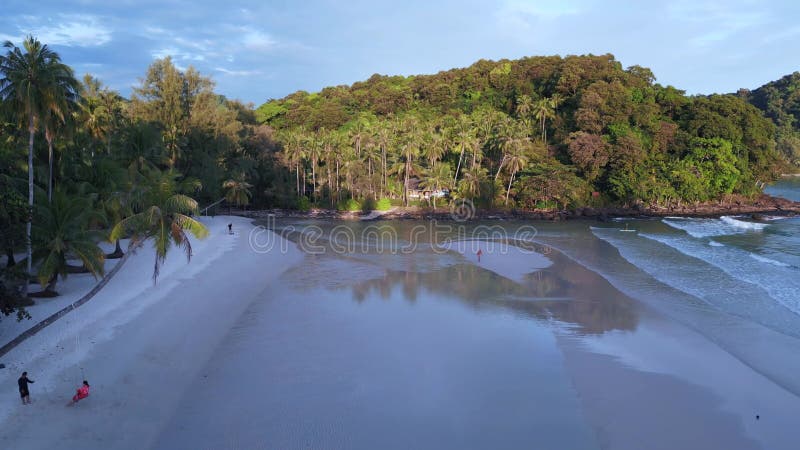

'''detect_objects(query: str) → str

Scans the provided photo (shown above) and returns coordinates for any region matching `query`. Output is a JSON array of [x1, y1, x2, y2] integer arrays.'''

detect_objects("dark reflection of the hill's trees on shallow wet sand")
[[278, 241, 638, 334]]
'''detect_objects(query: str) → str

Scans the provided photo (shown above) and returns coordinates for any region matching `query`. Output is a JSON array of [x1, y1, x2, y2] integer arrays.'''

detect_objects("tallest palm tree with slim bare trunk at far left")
[[0, 36, 79, 295]]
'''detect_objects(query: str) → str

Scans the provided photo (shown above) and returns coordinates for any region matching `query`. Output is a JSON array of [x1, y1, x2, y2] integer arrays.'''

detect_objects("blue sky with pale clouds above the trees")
[[0, 0, 800, 106]]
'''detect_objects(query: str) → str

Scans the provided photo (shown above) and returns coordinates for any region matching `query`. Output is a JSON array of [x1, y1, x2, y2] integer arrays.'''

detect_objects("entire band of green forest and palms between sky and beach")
[[0, 37, 800, 313]]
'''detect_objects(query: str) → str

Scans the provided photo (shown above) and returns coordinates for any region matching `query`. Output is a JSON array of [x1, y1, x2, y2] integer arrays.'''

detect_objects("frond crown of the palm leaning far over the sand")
[[109, 168, 208, 283]]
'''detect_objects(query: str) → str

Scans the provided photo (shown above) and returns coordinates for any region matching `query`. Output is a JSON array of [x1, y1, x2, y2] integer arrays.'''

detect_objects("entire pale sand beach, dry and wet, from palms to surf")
[[0, 216, 800, 450]]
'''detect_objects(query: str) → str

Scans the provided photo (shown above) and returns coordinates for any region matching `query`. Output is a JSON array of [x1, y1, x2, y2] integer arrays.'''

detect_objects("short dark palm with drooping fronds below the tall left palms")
[[33, 190, 105, 295]]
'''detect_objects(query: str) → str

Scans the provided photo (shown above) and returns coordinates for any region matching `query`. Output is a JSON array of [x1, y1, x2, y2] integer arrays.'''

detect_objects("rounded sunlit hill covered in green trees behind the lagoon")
[[256, 55, 785, 208]]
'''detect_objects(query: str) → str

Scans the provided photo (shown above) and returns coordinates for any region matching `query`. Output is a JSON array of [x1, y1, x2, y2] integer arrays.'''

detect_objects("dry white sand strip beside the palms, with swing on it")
[[0, 216, 300, 449]]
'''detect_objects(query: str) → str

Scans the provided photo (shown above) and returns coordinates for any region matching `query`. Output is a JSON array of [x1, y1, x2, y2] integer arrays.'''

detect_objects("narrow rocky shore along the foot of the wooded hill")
[[233, 194, 800, 221]]
